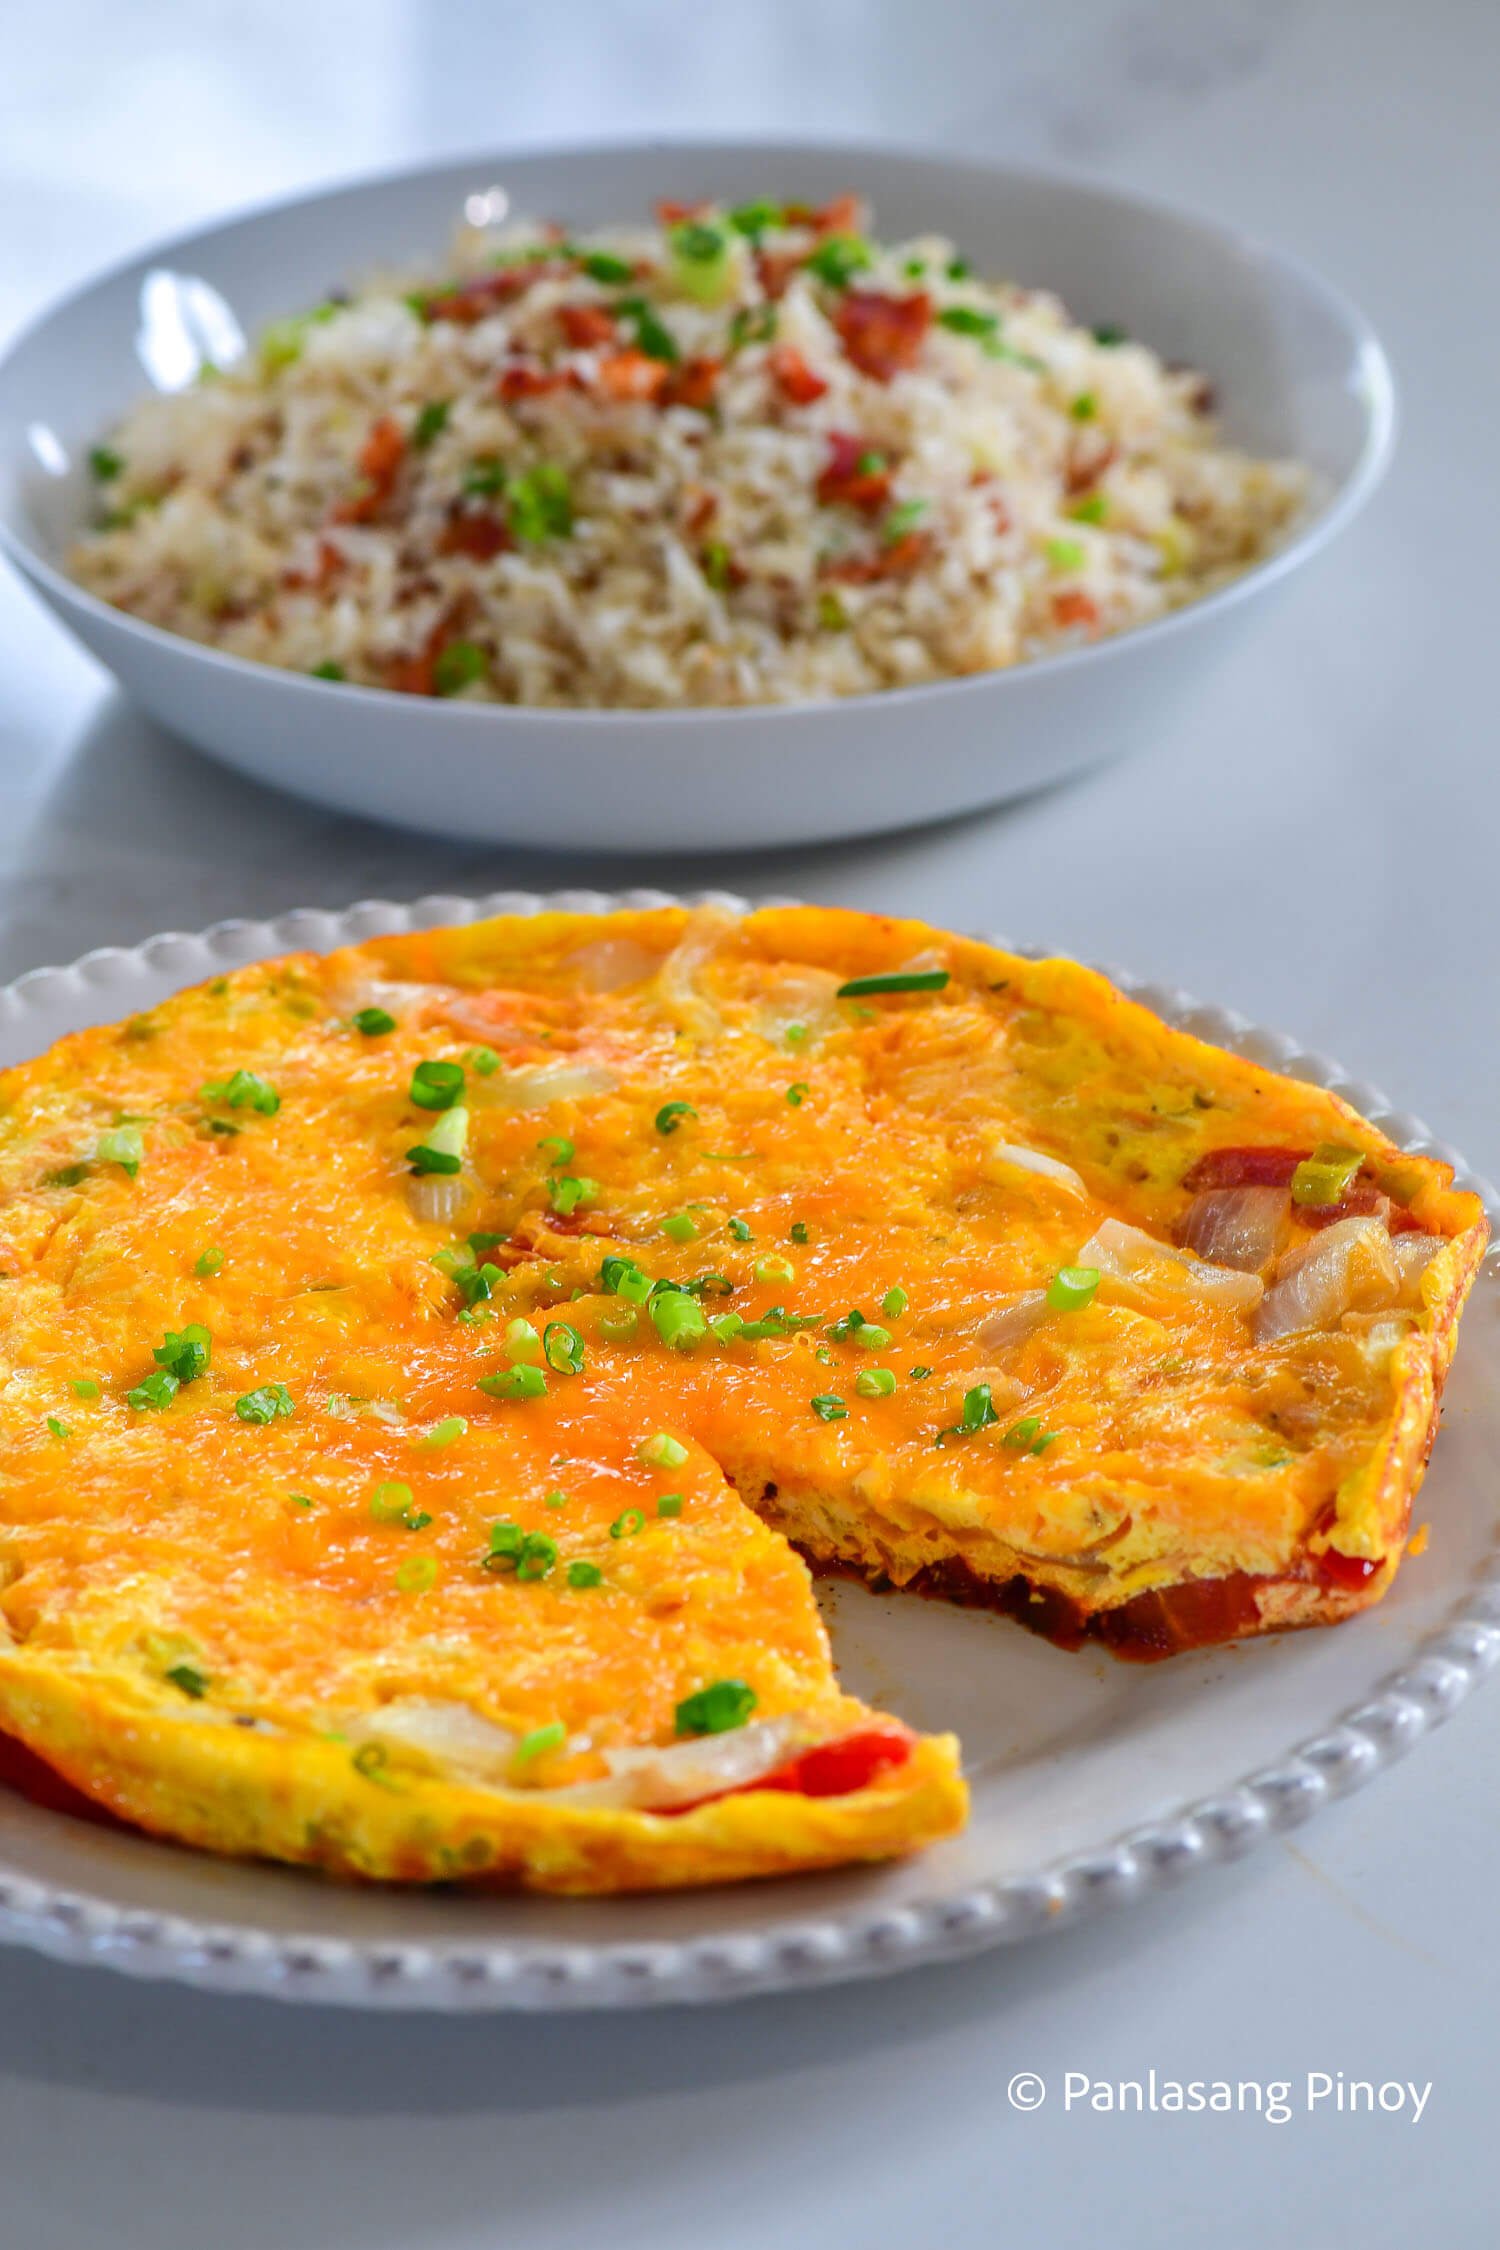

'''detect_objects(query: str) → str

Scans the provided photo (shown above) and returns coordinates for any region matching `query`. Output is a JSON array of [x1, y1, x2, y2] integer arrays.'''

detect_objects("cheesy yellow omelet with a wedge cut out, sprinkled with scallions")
[[0, 909, 1487, 1892]]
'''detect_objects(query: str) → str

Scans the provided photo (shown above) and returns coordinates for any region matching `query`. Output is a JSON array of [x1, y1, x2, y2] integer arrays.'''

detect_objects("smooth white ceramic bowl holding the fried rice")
[[0, 142, 1394, 851]]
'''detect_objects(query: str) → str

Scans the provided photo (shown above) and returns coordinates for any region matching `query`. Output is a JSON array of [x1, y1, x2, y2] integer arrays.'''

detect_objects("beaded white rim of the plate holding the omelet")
[[0, 889, 1500, 2012]]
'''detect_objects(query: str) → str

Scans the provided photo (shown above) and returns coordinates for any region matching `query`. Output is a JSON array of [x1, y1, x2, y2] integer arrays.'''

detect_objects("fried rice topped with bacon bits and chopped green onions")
[[70, 198, 1309, 709]]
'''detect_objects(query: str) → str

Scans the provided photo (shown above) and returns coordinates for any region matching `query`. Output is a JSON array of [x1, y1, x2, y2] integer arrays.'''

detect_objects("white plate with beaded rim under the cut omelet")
[[0, 891, 1500, 2009]]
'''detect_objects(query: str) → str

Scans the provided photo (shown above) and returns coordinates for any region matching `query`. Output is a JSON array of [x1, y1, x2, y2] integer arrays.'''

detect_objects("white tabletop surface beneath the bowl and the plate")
[[0, 0, 1500, 2250]]
